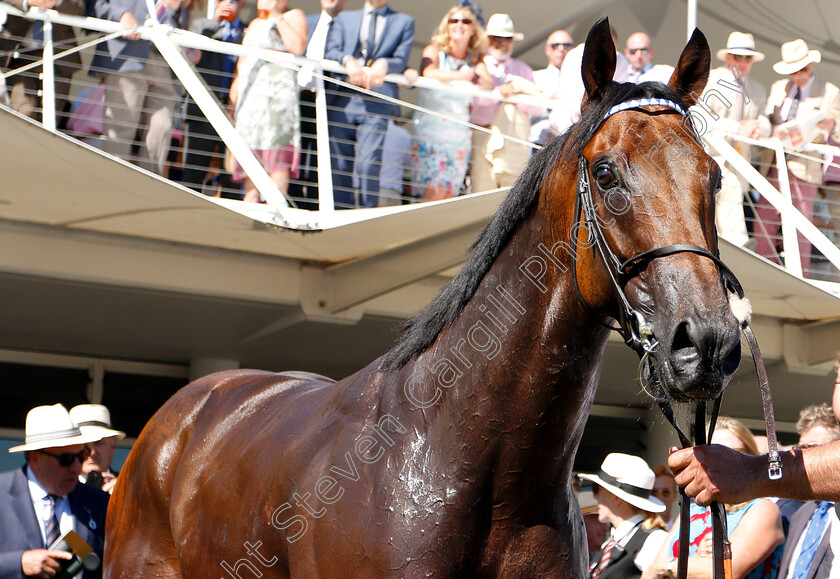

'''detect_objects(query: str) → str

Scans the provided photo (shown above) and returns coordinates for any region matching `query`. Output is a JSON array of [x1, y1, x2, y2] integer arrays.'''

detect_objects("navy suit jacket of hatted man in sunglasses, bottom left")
[[0, 466, 110, 579]]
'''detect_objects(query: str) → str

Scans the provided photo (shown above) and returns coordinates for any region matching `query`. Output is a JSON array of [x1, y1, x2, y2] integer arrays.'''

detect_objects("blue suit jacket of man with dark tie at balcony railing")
[[324, 6, 414, 114]]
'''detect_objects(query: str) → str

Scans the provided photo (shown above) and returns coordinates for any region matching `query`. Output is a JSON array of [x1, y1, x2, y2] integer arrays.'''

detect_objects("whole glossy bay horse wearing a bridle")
[[104, 20, 740, 579]]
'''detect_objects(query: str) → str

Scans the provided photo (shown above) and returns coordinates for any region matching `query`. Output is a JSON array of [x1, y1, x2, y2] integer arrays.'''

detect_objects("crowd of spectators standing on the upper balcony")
[[0, 0, 840, 270]]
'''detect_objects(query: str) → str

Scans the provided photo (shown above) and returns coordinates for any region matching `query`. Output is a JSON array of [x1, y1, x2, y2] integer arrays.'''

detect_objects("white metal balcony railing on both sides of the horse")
[[0, 2, 840, 281]]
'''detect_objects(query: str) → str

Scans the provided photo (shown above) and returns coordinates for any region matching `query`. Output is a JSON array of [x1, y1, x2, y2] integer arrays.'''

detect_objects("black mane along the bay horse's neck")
[[380, 82, 686, 372]]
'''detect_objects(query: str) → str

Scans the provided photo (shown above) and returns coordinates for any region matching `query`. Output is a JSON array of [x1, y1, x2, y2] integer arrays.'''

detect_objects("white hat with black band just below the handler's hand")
[[578, 452, 665, 513]]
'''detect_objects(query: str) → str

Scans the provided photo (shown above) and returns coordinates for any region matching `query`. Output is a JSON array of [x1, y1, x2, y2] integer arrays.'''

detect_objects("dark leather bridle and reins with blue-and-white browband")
[[571, 98, 782, 579]]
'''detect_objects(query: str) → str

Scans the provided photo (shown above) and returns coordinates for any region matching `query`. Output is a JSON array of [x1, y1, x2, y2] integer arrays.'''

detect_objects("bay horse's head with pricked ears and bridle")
[[572, 20, 740, 400]]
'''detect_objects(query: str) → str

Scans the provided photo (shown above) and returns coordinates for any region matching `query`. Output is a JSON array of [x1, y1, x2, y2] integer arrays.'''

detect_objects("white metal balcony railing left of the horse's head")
[[0, 2, 552, 229]]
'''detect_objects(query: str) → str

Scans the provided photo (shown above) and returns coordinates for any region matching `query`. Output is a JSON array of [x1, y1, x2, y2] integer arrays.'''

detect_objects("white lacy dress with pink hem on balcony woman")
[[232, 18, 300, 181]]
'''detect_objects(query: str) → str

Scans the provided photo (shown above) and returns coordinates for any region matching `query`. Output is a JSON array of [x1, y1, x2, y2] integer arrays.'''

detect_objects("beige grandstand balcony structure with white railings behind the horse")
[[0, 0, 840, 470]]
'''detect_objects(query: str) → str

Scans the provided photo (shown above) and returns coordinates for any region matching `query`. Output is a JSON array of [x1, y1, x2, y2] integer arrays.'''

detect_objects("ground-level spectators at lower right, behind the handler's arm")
[[575, 403, 840, 579]]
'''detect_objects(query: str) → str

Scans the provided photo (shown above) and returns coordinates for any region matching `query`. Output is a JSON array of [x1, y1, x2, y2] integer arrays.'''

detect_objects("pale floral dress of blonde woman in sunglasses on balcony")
[[411, 51, 472, 197]]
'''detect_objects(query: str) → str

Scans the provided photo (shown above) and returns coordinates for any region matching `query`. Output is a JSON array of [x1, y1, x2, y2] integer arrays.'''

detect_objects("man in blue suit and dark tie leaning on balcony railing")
[[324, 0, 414, 208]]
